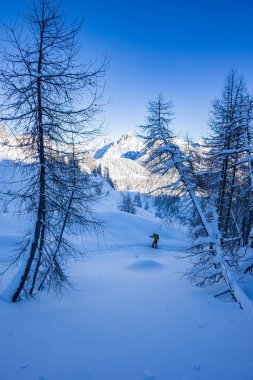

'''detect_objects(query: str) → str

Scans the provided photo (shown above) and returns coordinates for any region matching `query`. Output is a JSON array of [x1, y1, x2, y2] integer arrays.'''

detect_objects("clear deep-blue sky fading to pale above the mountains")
[[0, 0, 253, 139]]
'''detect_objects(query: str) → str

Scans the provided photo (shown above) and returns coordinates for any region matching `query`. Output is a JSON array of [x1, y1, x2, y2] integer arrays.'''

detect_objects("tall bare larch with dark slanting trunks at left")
[[0, 0, 106, 302]]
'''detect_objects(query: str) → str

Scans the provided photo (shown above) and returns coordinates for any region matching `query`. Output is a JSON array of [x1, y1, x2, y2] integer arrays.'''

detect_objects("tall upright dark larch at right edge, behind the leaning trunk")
[[202, 71, 253, 267]]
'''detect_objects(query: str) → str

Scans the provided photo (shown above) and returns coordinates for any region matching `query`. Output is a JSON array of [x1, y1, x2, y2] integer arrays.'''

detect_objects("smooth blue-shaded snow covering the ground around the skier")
[[0, 186, 253, 380]]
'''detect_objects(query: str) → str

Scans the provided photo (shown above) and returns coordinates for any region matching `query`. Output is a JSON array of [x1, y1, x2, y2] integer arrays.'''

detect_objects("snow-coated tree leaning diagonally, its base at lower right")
[[138, 91, 252, 308]]
